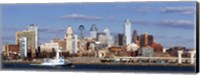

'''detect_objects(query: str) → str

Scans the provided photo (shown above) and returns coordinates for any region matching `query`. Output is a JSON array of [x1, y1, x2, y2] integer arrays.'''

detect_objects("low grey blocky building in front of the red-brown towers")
[[141, 46, 154, 57]]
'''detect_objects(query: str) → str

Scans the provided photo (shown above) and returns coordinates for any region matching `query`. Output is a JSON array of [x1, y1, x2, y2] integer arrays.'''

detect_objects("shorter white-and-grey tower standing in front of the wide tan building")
[[19, 37, 28, 58]]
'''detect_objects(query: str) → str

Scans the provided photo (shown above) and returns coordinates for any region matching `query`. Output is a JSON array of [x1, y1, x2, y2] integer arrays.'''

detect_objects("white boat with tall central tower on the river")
[[31, 48, 72, 66]]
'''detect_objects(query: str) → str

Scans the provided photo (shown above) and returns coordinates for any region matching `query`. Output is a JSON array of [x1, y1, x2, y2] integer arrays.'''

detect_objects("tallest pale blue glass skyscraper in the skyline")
[[124, 19, 132, 45]]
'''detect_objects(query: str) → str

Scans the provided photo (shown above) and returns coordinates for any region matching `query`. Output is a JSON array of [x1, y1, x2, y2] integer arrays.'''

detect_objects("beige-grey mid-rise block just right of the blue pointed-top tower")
[[96, 32, 108, 48]]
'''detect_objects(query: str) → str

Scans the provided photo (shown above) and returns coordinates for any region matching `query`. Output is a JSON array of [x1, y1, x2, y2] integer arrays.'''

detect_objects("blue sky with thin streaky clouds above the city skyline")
[[1, 2, 196, 48]]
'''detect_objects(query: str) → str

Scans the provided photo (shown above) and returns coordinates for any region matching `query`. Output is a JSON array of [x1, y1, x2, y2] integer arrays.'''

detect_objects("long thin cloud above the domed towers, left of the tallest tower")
[[61, 13, 102, 20]]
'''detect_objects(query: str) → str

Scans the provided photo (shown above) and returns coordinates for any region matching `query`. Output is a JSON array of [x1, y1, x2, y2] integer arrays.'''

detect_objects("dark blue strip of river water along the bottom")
[[2, 63, 195, 73]]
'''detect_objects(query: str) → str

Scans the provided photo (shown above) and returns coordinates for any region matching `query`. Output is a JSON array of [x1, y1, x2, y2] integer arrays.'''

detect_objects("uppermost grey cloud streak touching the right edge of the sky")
[[160, 6, 195, 15]]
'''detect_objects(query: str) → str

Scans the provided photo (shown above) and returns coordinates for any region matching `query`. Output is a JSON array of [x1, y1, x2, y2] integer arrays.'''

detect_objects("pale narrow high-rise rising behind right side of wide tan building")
[[28, 24, 38, 49]]
